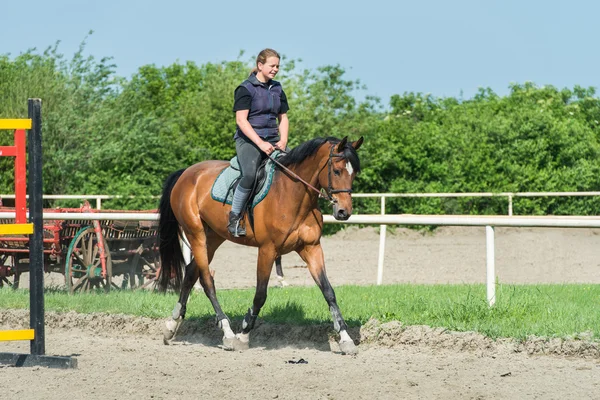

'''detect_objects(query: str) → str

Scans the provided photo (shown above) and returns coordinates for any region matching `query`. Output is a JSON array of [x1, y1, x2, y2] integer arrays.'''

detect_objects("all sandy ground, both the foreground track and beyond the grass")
[[0, 227, 600, 399]]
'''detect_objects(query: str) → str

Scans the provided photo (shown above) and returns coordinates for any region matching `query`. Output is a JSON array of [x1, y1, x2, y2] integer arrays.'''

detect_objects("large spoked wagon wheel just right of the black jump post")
[[65, 226, 112, 293]]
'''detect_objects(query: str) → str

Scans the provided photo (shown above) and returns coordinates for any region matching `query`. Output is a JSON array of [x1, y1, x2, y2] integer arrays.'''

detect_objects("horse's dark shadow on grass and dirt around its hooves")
[[173, 301, 360, 352]]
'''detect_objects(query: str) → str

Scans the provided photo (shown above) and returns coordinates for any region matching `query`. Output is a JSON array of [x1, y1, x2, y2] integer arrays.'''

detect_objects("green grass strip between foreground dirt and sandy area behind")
[[0, 284, 600, 340]]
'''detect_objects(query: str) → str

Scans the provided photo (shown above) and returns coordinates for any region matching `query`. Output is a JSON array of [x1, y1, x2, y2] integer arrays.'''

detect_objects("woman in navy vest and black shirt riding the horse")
[[228, 49, 289, 237]]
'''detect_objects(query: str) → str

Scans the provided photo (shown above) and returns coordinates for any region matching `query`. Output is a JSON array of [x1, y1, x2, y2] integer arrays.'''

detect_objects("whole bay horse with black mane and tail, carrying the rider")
[[158, 137, 363, 354]]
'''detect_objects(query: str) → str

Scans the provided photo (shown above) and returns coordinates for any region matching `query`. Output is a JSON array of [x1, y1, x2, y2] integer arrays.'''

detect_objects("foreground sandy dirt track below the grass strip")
[[0, 311, 600, 399]]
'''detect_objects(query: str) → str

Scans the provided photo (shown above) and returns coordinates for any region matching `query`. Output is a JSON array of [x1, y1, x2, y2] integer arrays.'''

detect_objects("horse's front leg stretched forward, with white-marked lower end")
[[298, 244, 358, 354]]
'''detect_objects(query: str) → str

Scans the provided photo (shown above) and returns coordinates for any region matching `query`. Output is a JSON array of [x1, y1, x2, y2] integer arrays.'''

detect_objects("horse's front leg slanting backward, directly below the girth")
[[236, 248, 277, 348]]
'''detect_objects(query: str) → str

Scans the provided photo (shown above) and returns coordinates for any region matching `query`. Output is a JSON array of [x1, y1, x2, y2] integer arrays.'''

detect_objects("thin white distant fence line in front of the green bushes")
[[0, 192, 600, 216]]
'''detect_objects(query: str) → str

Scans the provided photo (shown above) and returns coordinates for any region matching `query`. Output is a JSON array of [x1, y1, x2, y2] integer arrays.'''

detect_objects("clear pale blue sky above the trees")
[[0, 0, 600, 104]]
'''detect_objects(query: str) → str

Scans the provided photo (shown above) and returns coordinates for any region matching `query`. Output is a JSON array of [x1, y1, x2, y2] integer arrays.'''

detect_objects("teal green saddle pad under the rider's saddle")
[[210, 151, 281, 207]]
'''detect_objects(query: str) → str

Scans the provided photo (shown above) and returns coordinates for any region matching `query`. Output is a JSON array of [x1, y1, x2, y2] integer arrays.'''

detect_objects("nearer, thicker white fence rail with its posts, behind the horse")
[[0, 212, 600, 306]]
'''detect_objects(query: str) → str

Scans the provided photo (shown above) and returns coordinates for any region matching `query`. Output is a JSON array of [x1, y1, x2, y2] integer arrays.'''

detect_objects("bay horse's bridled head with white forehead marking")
[[319, 136, 363, 221]]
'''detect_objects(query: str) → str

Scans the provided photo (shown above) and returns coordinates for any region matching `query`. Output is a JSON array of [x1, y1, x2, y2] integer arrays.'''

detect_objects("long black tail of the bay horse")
[[158, 169, 185, 292]]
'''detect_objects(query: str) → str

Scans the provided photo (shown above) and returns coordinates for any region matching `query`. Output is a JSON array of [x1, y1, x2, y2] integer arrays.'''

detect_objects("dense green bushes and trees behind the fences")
[[0, 41, 600, 216]]
